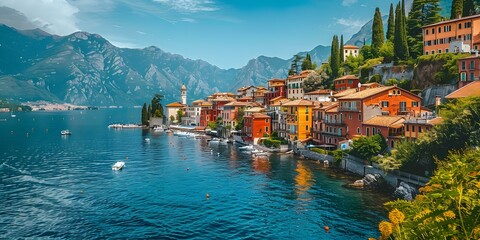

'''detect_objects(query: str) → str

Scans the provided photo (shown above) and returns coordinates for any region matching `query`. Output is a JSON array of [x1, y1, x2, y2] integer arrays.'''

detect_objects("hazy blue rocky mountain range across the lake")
[[0, 25, 330, 106]]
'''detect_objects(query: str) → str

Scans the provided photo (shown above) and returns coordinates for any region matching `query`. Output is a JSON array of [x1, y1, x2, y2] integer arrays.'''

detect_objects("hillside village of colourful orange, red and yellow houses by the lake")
[[162, 11, 480, 153]]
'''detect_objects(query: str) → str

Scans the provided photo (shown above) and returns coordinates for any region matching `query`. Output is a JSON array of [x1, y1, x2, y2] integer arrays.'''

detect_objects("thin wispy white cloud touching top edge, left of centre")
[[153, 0, 218, 13]]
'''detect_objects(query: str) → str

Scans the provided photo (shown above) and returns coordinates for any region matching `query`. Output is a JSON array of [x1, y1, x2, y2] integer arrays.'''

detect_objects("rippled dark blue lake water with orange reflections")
[[0, 109, 388, 239]]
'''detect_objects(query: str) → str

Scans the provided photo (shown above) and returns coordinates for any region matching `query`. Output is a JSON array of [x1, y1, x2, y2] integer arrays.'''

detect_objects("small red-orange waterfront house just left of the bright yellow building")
[[243, 113, 271, 144]]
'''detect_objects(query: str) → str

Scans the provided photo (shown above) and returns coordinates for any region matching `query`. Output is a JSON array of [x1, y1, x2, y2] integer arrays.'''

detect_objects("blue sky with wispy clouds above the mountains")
[[0, 0, 397, 68]]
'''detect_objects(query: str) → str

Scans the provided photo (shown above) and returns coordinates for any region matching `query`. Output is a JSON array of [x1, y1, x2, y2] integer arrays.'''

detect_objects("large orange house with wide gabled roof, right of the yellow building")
[[338, 86, 421, 138]]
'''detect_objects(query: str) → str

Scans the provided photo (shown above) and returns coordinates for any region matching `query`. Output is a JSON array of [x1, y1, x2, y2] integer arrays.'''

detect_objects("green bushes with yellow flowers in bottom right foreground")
[[379, 149, 480, 239]]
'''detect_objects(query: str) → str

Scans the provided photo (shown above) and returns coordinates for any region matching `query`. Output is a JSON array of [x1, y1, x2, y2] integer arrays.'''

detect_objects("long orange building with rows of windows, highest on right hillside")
[[423, 15, 480, 55]]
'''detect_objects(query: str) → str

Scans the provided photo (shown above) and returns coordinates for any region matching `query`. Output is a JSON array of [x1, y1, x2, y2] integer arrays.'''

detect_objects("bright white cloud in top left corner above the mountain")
[[0, 0, 79, 35]]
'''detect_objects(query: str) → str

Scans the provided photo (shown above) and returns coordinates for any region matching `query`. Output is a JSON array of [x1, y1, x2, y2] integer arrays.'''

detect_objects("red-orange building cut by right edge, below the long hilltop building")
[[457, 54, 480, 88]]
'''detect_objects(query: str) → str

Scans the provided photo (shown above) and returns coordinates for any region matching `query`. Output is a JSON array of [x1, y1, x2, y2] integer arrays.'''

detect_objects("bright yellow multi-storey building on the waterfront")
[[282, 99, 313, 141]]
